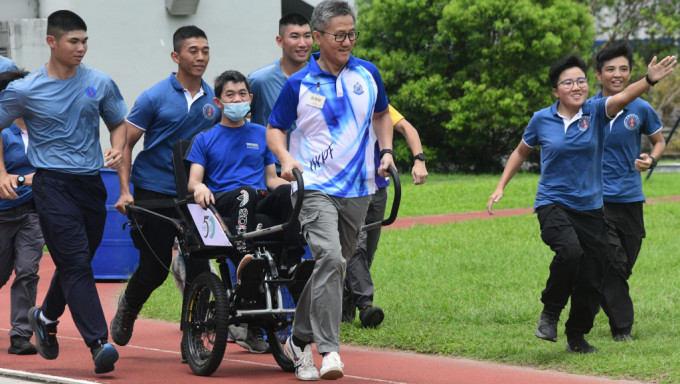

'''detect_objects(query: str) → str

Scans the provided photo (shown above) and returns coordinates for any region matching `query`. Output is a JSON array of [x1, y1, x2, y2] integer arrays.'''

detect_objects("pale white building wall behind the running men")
[[0, 0, 281, 158]]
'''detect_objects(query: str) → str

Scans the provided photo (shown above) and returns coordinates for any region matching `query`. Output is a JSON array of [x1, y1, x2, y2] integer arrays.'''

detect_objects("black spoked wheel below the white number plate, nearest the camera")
[[182, 272, 229, 376]]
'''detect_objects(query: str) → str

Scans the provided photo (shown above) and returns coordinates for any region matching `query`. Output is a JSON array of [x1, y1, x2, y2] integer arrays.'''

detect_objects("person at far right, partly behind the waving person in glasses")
[[594, 44, 666, 341]]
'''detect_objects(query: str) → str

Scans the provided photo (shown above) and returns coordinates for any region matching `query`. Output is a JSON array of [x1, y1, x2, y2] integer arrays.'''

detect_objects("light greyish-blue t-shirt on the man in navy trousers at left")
[[0, 64, 127, 175]]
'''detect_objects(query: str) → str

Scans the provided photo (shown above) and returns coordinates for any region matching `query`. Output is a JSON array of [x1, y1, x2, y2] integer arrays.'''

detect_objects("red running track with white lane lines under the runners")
[[0, 209, 660, 384]]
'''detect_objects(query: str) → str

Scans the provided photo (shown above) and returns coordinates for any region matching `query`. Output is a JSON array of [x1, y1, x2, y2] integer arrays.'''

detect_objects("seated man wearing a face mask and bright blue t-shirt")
[[187, 71, 297, 353]]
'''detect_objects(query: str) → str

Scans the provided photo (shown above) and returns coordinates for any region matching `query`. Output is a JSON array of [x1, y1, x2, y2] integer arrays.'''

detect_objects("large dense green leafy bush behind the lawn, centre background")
[[355, 0, 594, 172]]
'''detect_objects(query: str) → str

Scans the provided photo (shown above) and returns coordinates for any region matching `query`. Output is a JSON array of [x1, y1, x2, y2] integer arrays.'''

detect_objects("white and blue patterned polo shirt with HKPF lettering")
[[269, 53, 388, 197]]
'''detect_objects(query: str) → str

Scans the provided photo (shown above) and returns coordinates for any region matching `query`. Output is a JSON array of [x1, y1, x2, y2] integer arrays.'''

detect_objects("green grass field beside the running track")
[[142, 174, 680, 383]]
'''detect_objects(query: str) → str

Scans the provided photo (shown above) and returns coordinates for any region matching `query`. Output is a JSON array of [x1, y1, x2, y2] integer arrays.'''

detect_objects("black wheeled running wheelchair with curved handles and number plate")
[[127, 140, 401, 376]]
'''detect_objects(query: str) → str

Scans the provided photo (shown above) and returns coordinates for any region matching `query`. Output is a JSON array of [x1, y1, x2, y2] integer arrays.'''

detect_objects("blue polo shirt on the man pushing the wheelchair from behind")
[[128, 73, 221, 195]]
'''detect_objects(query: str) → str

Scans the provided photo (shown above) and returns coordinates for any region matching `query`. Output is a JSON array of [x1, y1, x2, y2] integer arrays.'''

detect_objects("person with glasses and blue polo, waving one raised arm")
[[487, 55, 676, 353]]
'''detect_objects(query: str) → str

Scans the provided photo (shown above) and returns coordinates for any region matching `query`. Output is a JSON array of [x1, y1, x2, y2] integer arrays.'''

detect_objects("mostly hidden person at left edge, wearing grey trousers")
[[0, 71, 45, 355]]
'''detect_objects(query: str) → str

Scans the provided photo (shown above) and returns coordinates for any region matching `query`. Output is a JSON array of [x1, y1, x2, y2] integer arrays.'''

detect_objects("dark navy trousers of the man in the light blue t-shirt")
[[33, 169, 108, 347]]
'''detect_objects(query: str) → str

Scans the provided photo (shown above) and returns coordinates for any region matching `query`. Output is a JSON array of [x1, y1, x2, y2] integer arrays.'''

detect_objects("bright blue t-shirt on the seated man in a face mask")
[[187, 123, 276, 193]]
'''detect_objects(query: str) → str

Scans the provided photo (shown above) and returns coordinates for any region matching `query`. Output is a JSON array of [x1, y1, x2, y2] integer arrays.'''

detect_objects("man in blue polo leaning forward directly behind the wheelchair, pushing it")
[[111, 26, 219, 345]]
